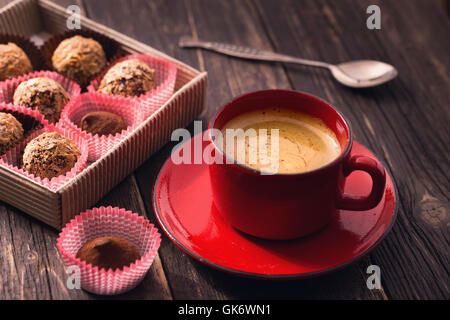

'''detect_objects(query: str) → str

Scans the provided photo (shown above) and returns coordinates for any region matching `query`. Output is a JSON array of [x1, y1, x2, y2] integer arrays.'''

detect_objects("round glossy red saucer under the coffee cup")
[[153, 135, 398, 279]]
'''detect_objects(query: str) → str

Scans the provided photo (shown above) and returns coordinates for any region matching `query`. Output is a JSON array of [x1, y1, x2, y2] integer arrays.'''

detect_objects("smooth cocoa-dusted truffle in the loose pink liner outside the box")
[[77, 236, 141, 270]]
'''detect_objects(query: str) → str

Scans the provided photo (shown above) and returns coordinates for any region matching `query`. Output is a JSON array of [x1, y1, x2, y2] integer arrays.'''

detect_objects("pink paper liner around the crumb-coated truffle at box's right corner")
[[87, 54, 177, 119]]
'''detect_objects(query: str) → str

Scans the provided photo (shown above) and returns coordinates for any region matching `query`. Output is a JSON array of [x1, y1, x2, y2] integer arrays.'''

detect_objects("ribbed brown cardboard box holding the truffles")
[[0, 0, 207, 229]]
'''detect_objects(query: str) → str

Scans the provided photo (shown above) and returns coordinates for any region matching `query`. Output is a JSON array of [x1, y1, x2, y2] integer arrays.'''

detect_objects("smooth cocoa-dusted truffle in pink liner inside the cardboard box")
[[80, 111, 127, 136]]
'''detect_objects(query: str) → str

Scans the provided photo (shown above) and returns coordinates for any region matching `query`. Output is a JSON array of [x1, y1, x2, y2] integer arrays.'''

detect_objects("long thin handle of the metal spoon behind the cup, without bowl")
[[178, 37, 331, 68]]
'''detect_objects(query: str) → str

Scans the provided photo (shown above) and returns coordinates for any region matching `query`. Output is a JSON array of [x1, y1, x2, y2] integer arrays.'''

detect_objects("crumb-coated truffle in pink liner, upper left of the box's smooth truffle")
[[13, 77, 70, 123]]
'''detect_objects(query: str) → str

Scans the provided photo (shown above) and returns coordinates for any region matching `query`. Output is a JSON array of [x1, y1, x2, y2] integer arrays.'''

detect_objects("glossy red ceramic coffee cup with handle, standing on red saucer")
[[209, 90, 386, 240]]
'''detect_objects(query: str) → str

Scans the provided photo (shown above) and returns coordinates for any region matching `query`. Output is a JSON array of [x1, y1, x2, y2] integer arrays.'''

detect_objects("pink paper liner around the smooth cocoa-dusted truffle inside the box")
[[58, 92, 143, 161]]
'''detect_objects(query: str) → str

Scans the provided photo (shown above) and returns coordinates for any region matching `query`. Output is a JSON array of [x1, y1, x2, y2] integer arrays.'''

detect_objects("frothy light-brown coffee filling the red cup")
[[220, 108, 341, 174]]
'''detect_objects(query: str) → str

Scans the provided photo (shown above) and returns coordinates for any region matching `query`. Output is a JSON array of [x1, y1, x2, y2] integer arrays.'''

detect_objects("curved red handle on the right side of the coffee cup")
[[336, 155, 386, 211]]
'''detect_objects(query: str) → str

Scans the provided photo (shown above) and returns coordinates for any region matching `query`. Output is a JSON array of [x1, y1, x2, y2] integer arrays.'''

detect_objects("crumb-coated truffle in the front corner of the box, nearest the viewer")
[[22, 132, 81, 180]]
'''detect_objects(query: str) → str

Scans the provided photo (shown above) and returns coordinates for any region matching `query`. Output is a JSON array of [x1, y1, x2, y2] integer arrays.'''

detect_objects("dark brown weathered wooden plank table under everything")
[[0, 0, 450, 299]]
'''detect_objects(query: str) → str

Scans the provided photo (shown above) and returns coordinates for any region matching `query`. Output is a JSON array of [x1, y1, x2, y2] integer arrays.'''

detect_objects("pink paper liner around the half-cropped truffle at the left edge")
[[0, 103, 48, 156]]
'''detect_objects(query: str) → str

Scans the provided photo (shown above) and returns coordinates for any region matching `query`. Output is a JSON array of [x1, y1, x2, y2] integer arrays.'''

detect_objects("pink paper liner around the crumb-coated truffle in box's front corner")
[[0, 124, 89, 191]]
